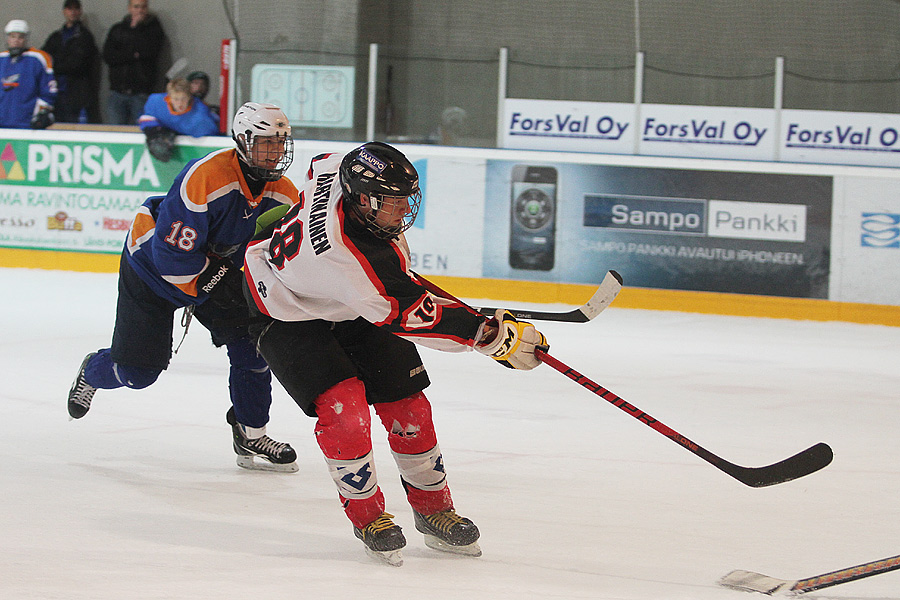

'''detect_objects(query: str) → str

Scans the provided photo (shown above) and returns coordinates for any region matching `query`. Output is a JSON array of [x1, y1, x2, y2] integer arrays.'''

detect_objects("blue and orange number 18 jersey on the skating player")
[[125, 149, 300, 306]]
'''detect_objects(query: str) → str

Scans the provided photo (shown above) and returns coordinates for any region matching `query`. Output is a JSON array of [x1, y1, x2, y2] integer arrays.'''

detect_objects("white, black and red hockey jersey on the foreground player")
[[244, 154, 486, 352]]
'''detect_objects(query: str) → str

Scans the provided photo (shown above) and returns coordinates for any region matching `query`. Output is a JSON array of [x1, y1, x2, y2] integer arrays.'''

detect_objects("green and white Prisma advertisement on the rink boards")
[[0, 134, 224, 253]]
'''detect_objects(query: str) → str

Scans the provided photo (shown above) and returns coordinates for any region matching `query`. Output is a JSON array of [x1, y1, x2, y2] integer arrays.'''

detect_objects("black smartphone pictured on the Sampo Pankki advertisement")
[[509, 165, 557, 271]]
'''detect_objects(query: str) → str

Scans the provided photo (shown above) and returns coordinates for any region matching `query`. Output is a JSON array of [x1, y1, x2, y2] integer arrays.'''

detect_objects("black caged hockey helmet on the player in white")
[[340, 142, 422, 239]]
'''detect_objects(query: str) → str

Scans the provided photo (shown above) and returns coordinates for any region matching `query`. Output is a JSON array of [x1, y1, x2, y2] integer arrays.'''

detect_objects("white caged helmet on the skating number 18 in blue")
[[231, 102, 294, 181]]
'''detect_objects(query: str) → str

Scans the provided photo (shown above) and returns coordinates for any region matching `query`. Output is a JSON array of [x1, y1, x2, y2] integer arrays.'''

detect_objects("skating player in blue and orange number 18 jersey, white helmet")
[[68, 102, 300, 472]]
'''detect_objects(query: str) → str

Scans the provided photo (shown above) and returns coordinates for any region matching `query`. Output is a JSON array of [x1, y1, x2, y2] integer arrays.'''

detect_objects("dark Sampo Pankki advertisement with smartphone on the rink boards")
[[483, 160, 833, 298]]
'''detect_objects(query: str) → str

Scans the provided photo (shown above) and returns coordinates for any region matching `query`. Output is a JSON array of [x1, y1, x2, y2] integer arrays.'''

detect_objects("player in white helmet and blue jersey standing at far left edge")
[[0, 19, 57, 129]]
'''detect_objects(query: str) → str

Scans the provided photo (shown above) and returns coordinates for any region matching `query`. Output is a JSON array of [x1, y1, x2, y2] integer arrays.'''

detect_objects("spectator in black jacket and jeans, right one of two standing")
[[103, 0, 165, 125]]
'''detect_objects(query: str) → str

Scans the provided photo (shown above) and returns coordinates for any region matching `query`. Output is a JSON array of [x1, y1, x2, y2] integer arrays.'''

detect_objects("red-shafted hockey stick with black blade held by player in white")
[[535, 349, 834, 487]]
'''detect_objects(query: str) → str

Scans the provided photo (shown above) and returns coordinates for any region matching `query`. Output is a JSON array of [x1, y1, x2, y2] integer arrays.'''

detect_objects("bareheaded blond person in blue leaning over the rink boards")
[[138, 79, 219, 162]]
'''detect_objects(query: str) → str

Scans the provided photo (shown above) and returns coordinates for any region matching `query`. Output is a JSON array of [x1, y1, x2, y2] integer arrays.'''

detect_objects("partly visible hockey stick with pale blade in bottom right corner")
[[719, 555, 900, 596]]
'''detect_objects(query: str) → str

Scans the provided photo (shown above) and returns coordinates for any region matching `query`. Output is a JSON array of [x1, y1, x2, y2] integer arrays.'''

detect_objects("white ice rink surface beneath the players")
[[0, 269, 900, 600]]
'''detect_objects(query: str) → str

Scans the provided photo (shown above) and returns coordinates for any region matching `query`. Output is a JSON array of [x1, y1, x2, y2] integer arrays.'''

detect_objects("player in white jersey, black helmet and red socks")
[[245, 142, 546, 565]]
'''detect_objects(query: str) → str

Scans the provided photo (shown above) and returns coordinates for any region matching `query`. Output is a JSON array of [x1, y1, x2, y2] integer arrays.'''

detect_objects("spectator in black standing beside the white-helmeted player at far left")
[[42, 0, 100, 123]]
